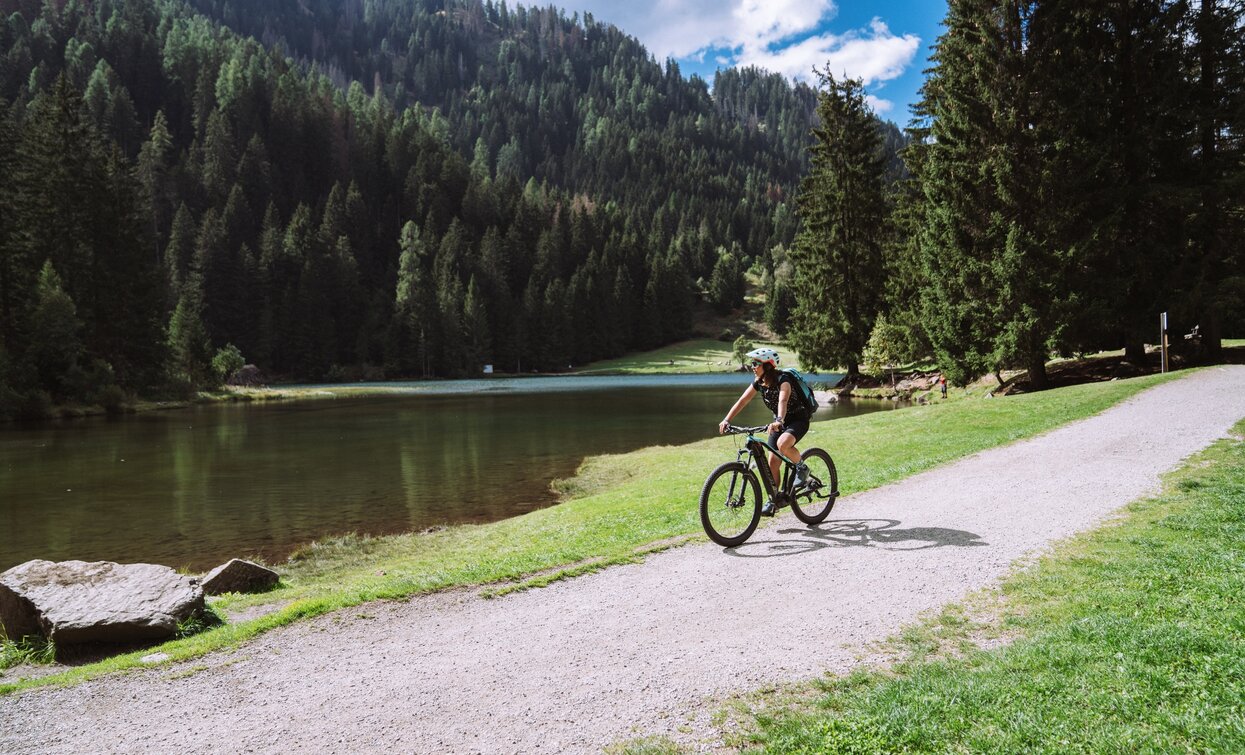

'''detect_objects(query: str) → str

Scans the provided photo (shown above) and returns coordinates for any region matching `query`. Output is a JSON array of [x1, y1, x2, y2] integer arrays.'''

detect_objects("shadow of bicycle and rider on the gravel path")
[[723, 520, 990, 558]]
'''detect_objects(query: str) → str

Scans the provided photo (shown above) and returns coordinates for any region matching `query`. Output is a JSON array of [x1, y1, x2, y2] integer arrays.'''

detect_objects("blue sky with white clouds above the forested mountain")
[[555, 0, 946, 126]]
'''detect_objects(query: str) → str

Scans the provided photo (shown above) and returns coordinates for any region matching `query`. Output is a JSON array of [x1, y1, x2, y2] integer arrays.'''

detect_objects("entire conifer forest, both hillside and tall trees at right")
[[0, 0, 1245, 417]]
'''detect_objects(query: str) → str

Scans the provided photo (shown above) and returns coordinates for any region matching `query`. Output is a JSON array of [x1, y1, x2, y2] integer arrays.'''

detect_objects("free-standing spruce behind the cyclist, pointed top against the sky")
[[788, 72, 889, 375]]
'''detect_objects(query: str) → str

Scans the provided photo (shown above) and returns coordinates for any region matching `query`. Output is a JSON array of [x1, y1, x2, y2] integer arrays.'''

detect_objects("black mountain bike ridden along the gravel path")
[[700, 425, 839, 548]]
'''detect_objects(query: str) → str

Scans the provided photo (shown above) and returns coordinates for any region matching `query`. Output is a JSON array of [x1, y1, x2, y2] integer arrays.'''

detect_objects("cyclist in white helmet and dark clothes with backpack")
[[717, 349, 812, 517]]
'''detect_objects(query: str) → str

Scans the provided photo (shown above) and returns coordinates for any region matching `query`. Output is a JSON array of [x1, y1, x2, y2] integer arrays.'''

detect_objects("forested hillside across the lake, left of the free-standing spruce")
[[0, 0, 846, 414]]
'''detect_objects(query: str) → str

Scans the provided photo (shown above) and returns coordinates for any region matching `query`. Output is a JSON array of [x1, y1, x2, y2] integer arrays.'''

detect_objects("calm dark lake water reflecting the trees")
[[0, 375, 891, 571]]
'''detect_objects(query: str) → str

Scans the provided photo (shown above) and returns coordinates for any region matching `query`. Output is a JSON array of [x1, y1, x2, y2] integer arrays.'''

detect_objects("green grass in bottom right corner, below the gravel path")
[[751, 413, 1245, 753]]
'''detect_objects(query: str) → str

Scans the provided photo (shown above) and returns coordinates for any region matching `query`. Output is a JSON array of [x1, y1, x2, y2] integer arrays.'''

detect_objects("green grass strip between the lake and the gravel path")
[[0, 374, 1173, 694]]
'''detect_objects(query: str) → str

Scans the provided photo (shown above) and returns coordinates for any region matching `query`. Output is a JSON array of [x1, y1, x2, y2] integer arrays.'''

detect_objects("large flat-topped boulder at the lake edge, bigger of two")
[[0, 561, 204, 645]]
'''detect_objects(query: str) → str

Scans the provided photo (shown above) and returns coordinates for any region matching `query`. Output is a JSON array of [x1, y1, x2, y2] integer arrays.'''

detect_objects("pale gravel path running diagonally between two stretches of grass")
[[0, 366, 1245, 753]]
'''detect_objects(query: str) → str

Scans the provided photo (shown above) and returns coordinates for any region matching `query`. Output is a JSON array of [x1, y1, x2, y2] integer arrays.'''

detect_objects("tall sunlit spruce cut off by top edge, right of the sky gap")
[[905, 0, 1079, 387]]
